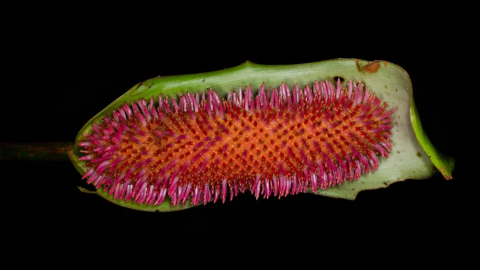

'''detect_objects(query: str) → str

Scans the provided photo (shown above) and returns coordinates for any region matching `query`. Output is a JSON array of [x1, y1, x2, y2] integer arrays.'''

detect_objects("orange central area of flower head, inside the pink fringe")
[[105, 98, 386, 190]]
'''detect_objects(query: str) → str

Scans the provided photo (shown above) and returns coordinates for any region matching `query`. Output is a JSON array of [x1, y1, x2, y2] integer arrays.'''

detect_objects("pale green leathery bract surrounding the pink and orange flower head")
[[0, 59, 454, 212]]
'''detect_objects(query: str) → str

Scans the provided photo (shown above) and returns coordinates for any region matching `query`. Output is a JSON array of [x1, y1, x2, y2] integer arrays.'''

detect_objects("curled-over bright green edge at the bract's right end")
[[410, 97, 455, 180]]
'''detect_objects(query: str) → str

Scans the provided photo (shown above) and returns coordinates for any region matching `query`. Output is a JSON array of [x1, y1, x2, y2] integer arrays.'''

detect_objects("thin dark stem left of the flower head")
[[0, 142, 73, 161]]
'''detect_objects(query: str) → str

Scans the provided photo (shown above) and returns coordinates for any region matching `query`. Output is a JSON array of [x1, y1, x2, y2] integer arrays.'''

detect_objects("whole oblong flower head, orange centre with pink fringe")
[[79, 81, 395, 205]]
